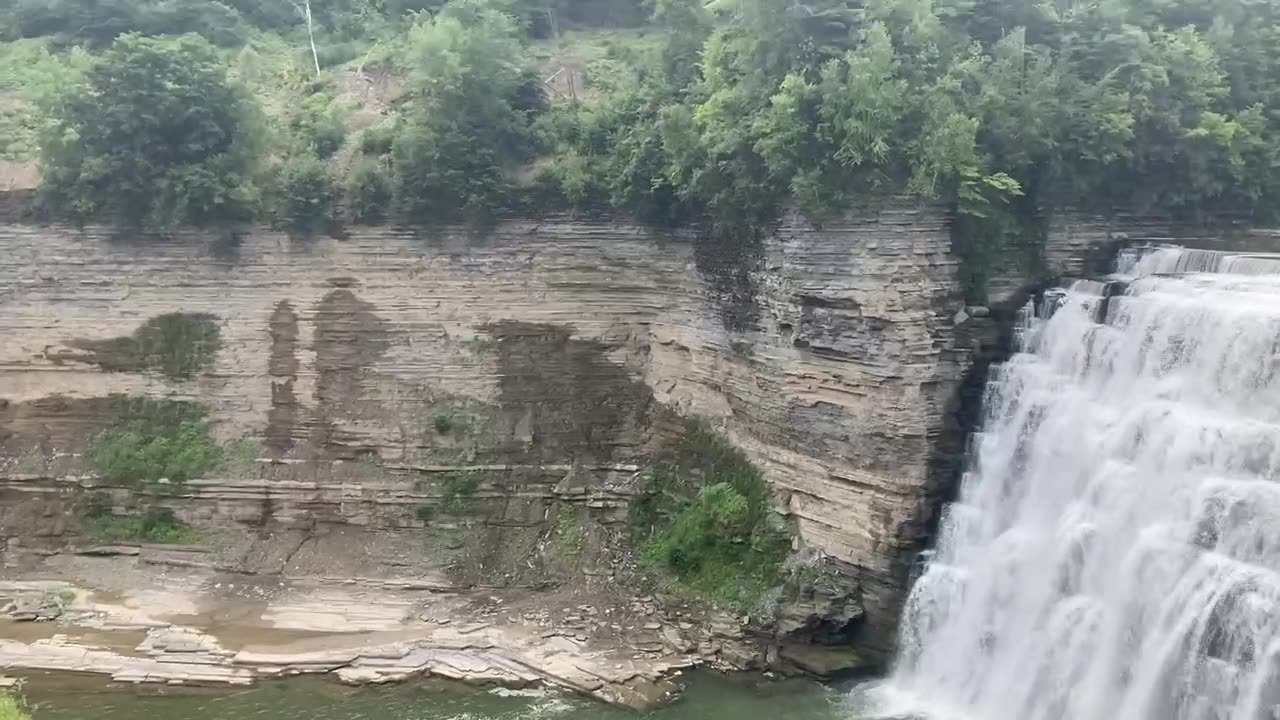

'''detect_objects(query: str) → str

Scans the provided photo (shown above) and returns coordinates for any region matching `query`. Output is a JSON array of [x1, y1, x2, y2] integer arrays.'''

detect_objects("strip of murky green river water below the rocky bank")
[[24, 674, 880, 720]]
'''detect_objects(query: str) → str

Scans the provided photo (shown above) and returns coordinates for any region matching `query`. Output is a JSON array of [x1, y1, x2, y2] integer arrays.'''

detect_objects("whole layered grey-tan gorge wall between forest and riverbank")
[[0, 201, 1141, 656]]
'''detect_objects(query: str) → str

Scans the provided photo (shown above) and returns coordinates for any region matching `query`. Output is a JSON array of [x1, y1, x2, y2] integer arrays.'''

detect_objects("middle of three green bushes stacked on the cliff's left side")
[[84, 397, 224, 484]]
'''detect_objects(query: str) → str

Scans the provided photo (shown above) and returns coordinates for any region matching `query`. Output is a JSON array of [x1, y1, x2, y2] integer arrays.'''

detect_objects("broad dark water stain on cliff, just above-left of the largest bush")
[[485, 320, 652, 462]]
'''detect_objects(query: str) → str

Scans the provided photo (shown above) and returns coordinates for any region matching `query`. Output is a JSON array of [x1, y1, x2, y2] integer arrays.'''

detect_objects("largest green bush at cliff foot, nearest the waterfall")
[[631, 421, 791, 610]]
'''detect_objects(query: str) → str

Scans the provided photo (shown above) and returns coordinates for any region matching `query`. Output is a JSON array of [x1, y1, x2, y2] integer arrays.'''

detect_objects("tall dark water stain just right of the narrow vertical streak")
[[312, 288, 390, 451]]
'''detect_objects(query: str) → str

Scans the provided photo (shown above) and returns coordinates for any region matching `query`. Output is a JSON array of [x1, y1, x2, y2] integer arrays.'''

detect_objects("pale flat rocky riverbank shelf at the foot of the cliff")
[[0, 546, 808, 707]]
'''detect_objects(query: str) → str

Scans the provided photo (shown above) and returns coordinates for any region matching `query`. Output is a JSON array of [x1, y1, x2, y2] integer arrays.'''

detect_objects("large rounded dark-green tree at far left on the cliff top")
[[41, 35, 255, 228]]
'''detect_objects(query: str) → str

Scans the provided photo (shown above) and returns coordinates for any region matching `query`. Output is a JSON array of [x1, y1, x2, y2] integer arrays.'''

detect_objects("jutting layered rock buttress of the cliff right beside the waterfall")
[[648, 201, 969, 655]]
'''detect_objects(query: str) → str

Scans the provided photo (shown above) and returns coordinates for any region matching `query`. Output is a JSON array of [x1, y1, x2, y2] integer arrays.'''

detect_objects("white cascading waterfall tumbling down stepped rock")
[[863, 247, 1280, 720]]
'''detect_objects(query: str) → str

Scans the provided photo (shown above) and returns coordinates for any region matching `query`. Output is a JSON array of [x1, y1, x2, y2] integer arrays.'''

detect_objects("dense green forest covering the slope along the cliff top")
[[0, 0, 1280, 294]]
